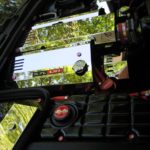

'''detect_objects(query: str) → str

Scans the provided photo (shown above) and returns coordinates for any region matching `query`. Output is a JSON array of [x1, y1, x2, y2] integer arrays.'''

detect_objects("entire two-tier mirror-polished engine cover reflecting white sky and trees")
[[13, 12, 115, 88]]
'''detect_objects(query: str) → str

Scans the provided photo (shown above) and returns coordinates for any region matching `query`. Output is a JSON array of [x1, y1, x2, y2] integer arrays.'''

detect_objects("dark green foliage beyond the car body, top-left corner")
[[0, 0, 26, 24]]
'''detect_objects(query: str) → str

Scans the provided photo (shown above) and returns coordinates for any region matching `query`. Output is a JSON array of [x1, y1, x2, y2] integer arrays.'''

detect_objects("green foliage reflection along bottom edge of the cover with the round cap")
[[17, 66, 92, 88]]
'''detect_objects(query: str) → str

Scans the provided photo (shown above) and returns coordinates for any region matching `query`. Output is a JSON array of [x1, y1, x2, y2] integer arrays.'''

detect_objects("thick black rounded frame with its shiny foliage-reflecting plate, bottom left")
[[0, 88, 50, 150]]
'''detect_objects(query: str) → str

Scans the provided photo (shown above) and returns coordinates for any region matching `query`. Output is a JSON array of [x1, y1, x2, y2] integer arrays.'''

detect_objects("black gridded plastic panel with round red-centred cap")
[[41, 92, 150, 140]]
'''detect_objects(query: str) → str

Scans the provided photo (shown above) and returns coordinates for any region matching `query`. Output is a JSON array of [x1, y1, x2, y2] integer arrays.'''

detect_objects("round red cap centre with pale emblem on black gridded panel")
[[54, 105, 70, 120]]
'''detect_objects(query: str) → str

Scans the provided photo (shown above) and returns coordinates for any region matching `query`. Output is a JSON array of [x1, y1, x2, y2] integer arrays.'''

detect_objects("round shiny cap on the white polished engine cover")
[[72, 60, 88, 76]]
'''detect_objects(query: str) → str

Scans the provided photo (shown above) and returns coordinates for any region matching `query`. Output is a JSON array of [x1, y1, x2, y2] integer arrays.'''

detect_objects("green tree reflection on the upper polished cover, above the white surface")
[[22, 14, 114, 54]]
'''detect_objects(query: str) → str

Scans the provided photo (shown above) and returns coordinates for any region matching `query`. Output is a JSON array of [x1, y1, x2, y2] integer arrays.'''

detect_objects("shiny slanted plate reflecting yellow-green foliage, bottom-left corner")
[[0, 104, 37, 150]]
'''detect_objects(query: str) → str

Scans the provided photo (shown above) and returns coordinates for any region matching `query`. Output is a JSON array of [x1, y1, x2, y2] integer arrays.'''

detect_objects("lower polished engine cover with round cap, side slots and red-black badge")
[[14, 44, 93, 88]]
